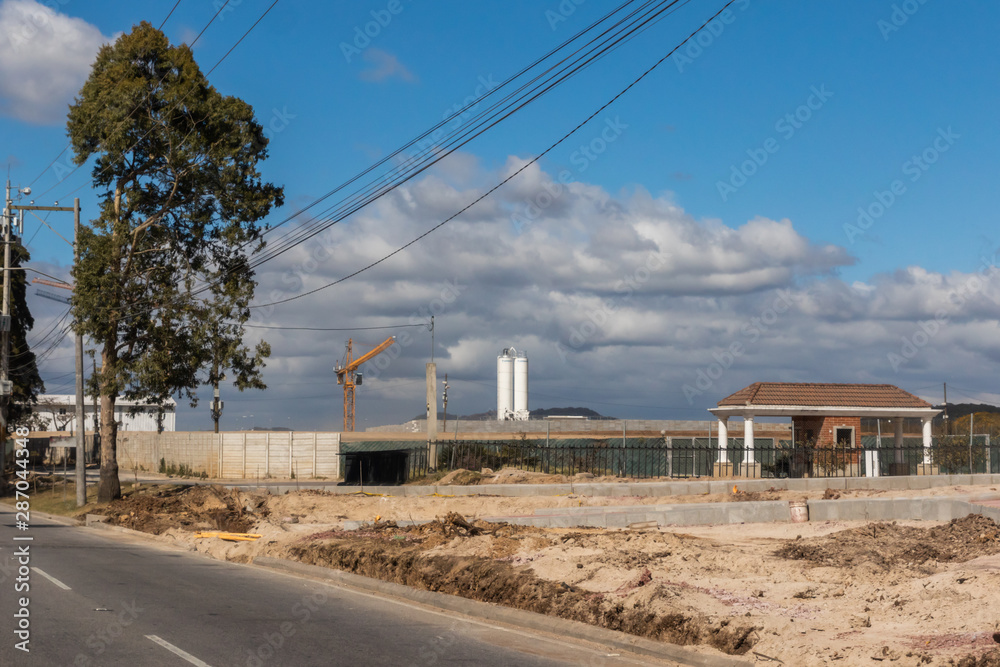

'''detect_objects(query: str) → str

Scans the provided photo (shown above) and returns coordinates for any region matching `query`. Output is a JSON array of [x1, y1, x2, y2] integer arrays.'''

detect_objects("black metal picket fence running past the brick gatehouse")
[[409, 435, 1000, 478]]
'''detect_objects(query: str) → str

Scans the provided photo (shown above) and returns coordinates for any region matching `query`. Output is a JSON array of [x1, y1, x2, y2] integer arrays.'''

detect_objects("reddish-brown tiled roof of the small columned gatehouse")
[[719, 382, 934, 408]]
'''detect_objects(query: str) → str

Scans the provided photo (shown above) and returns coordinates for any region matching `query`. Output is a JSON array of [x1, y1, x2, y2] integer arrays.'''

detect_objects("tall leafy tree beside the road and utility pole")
[[67, 22, 282, 502]]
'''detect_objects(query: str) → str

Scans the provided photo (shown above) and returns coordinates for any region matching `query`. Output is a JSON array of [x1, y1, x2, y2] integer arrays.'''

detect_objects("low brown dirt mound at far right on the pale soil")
[[775, 514, 1000, 571]]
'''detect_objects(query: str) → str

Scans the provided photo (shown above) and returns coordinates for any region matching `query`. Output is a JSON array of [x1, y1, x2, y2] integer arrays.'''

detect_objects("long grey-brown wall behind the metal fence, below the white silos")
[[365, 419, 791, 439]]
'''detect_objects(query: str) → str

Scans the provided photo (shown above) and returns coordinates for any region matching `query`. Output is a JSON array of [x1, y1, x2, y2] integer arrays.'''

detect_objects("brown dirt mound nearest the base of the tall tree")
[[104, 485, 268, 535]]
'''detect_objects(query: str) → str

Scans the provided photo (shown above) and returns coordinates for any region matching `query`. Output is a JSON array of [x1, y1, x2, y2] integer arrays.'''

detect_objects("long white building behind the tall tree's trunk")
[[32, 394, 177, 433]]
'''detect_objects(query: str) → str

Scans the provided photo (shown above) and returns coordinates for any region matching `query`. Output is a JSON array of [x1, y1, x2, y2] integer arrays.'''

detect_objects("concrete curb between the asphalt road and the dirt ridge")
[[253, 556, 753, 667]]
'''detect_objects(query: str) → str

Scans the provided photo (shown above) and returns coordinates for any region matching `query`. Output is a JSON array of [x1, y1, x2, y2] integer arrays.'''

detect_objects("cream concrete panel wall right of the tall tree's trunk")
[[118, 431, 340, 479]]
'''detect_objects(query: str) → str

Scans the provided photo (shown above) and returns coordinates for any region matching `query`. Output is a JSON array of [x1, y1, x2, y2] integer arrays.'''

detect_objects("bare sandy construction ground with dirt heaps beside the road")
[[88, 473, 1000, 667]]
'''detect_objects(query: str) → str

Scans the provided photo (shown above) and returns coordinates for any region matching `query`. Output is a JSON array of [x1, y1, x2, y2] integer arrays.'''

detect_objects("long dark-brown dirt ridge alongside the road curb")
[[287, 514, 756, 655]]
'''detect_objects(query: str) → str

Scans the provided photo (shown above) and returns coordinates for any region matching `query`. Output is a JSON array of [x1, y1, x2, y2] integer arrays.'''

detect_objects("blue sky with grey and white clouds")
[[0, 0, 1000, 429]]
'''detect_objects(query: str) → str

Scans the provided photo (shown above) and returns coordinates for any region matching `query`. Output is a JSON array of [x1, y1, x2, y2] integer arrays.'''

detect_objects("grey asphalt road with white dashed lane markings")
[[0, 506, 665, 667]]
